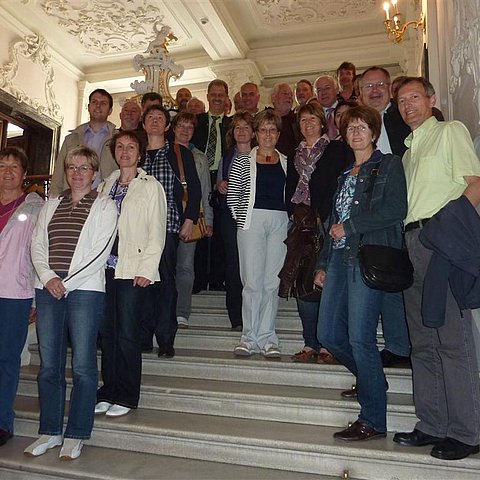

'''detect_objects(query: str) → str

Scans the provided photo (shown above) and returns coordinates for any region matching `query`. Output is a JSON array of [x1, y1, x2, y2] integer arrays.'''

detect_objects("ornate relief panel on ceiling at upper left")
[[41, 0, 169, 53]]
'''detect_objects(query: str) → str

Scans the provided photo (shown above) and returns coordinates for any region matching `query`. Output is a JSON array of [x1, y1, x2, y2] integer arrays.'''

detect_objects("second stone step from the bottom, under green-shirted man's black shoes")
[[15, 396, 480, 480]]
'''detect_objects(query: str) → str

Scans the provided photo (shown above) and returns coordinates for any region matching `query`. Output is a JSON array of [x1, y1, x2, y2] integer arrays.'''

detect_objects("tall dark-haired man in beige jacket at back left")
[[49, 88, 118, 197]]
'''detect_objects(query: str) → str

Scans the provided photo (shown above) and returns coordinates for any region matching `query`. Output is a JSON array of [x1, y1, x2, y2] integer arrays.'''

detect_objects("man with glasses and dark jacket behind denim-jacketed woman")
[[360, 67, 411, 367]]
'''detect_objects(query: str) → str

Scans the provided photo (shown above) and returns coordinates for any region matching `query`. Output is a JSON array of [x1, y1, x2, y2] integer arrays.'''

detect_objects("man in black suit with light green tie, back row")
[[192, 79, 231, 293]]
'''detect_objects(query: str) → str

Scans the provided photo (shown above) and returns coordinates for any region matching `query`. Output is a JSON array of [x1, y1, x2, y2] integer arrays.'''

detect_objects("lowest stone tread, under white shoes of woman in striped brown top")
[[0, 436, 326, 480]]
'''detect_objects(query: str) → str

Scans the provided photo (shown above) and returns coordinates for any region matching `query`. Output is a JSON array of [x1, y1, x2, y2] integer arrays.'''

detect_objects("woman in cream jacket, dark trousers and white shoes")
[[95, 131, 167, 417]]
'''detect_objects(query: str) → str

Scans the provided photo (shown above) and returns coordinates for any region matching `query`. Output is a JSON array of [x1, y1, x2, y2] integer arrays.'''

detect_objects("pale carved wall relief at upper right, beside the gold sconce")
[[449, 0, 480, 125]]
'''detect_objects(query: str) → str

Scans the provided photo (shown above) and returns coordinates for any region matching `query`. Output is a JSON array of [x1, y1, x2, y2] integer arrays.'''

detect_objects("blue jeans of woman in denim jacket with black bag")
[[318, 249, 387, 432]]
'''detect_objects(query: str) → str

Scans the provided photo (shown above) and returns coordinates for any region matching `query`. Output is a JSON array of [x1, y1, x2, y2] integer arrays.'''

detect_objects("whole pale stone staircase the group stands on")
[[0, 293, 480, 480]]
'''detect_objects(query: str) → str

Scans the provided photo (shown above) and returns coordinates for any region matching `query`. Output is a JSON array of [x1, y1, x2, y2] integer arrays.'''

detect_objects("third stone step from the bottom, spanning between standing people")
[[18, 366, 416, 431]]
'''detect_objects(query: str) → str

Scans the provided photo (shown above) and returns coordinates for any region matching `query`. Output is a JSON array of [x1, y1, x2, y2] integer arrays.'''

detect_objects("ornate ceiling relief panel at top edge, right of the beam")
[[255, 0, 376, 26]]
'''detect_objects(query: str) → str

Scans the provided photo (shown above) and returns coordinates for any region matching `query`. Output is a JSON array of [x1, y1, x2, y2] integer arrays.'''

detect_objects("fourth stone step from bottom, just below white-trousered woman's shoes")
[[30, 345, 412, 394]]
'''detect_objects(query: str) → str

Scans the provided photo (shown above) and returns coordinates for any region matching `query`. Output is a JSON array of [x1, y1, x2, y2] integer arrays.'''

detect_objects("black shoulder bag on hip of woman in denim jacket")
[[358, 162, 413, 293]]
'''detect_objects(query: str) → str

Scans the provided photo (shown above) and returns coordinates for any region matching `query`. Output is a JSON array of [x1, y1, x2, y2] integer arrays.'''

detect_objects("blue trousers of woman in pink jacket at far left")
[[0, 298, 32, 432]]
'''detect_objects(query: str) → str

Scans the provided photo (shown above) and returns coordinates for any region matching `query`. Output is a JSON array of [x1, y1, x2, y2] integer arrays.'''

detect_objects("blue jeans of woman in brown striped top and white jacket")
[[35, 289, 104, 439]]
